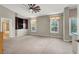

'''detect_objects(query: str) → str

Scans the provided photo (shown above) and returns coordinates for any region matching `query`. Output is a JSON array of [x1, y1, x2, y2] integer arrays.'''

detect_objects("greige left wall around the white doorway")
[[0, 5, 15, 37]]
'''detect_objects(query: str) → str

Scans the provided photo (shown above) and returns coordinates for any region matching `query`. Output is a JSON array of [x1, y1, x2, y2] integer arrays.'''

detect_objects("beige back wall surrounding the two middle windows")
[[28, 14, 63, 38]]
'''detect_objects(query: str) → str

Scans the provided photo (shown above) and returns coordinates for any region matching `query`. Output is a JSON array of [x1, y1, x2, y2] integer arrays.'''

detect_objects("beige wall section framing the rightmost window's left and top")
[[63, 7, 77, 41]]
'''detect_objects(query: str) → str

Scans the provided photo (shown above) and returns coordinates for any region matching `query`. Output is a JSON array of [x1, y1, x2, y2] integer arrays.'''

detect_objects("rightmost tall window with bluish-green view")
[[69, 17, 77, 35]]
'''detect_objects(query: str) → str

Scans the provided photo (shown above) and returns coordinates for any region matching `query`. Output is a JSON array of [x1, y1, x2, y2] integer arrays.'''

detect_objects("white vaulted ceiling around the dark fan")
[[2, 4, 68, 18]]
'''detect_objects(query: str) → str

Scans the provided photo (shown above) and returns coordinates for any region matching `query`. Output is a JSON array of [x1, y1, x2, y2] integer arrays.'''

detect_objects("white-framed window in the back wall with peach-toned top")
[[50, 17, 60, 33]]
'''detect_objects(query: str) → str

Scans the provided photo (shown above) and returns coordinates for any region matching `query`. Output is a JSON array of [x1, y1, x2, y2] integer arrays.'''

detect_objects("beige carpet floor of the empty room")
[[4, 36, 72, 54]]
